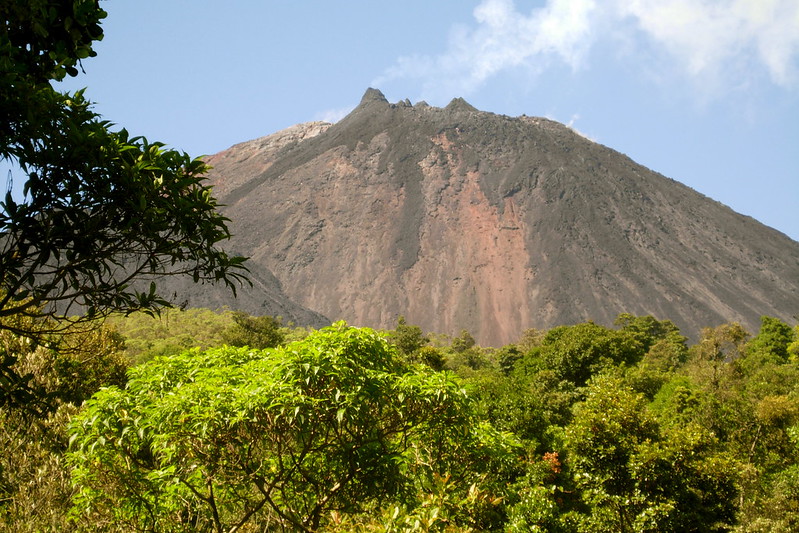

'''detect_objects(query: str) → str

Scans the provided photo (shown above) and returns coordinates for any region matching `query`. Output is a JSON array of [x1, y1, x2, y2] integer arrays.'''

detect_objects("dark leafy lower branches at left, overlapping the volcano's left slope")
[[0, 89, 246, 324]]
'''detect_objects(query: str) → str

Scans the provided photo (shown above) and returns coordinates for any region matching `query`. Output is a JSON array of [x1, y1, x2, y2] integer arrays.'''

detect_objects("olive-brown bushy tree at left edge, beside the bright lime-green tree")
[[0, 310, 127, 533]]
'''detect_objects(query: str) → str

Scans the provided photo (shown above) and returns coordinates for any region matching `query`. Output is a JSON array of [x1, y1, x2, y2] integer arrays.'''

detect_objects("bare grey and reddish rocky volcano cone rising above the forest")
[[202, 89, 799, 346]]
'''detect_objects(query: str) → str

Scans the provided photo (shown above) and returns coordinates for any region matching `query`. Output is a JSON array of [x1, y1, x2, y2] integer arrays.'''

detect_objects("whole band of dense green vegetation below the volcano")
[[0, 310, 799, 532]]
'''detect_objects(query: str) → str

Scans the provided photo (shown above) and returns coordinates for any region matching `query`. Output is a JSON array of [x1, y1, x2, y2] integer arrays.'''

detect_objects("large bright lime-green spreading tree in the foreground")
[[71, 323, 501, 531]]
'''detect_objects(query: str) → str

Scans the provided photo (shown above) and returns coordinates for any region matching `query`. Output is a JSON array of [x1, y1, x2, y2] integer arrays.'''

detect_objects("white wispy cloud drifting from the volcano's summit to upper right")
[[374, 0, 799, 97]]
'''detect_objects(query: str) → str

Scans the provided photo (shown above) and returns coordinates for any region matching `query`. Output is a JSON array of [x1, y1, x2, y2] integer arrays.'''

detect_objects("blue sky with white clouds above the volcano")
[[56, 0, 799, 240]]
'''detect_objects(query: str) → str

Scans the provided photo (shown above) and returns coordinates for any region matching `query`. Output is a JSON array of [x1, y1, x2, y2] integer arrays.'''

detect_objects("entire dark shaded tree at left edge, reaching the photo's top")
[[0, 0, 246, 404]]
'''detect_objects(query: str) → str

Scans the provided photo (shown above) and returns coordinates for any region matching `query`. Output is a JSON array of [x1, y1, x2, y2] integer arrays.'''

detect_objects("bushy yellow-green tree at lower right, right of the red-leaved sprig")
[[566, 376, 740, 533]]
